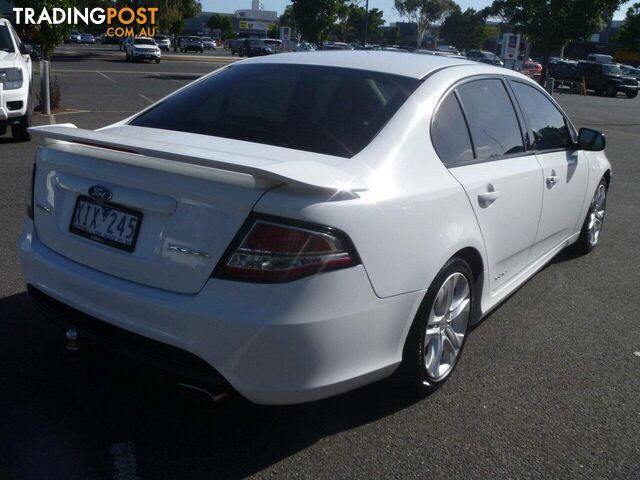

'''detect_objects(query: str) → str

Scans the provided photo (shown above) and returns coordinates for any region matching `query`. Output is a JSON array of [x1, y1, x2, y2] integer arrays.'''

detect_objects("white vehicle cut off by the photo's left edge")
[[0, 18, 33, 141]]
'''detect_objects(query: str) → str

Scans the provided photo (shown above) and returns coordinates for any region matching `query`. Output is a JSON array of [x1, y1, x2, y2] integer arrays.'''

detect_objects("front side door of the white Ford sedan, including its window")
[[510, 80, 589, 261]]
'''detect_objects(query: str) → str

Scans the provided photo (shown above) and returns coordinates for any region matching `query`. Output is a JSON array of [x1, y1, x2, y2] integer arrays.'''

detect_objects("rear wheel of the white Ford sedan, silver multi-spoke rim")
[[397, 257, 475, 395]]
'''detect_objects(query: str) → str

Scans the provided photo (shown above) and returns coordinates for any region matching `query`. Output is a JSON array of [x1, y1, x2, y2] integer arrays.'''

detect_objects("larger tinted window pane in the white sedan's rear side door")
[[457, 79, 524, 160]]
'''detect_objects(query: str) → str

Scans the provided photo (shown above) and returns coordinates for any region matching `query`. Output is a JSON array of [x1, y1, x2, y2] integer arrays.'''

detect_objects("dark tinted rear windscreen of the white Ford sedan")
[[130, 64, 420, 158]]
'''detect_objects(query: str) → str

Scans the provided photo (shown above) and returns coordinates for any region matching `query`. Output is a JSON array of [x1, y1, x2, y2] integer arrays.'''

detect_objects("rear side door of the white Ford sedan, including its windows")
[[432, 77, 542, 291]]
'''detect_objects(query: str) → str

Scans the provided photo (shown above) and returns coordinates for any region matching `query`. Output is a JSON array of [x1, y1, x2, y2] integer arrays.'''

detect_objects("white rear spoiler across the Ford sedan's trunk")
[[29, 124, 368, 193]]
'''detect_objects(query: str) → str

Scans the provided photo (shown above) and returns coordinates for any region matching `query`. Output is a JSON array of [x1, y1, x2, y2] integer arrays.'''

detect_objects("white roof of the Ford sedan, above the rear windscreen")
[[242, 50, 478, 79]]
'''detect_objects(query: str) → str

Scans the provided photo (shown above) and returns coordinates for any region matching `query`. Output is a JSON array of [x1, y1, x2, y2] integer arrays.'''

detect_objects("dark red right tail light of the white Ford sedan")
[[214, 217, 360, 283]]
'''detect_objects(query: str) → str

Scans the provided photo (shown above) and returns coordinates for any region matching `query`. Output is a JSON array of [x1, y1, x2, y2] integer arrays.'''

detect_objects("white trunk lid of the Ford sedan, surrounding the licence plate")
[[31, 125, 362, 294]]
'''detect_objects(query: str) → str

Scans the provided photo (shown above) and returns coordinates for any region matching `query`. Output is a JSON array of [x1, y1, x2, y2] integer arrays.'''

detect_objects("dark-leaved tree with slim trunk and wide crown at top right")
[[490, 0, 621, 85]]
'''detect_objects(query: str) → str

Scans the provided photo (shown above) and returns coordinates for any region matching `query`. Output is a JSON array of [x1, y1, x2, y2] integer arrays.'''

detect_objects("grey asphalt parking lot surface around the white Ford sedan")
[[0, 51, 640, 480]]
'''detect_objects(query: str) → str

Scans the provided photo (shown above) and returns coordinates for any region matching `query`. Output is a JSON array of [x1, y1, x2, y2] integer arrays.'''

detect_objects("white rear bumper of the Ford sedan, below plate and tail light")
[[18, 221, 424, 404]]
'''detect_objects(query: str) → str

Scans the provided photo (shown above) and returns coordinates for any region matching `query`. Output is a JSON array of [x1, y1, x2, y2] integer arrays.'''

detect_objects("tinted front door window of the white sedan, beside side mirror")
[[512, 82, 571, 151]]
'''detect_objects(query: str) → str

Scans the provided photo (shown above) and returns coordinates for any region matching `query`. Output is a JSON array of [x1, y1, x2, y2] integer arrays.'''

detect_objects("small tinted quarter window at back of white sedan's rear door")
[[431, 93, 473, 167]]
